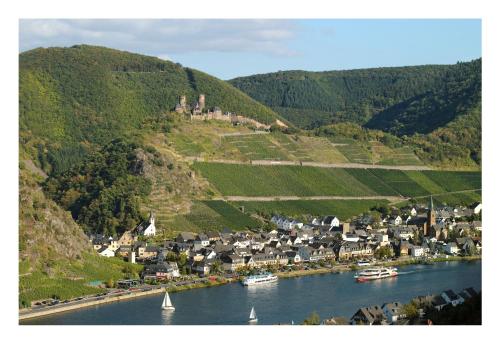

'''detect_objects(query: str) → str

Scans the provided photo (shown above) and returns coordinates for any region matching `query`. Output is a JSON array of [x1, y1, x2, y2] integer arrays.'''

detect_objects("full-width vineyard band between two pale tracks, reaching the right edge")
[[194, 162, 481, 197]]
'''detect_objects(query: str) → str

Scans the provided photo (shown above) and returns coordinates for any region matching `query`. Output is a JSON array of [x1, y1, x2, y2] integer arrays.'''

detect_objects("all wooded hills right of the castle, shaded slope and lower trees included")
[[230, 59, 482, 168]]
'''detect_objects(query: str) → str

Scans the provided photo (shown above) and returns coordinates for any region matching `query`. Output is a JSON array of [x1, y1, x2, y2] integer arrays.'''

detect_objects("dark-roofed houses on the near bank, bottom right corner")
[[350, 287, 478, 325]]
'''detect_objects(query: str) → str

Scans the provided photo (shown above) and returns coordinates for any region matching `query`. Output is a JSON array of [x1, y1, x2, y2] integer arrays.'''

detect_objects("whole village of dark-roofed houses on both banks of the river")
[[84, 195, 482, 325]]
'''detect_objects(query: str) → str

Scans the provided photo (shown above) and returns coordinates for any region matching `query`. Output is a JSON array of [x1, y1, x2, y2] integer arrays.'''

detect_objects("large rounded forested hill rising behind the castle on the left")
[[19, 45, 277, 171]]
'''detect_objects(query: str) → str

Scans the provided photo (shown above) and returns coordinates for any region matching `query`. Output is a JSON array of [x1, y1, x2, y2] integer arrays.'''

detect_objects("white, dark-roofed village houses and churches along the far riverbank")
[[92, 201, 481, 280]]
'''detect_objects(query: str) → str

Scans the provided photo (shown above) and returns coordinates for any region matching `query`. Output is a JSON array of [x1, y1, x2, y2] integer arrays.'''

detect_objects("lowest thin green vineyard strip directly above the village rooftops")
[[232, 200, 388, 220]]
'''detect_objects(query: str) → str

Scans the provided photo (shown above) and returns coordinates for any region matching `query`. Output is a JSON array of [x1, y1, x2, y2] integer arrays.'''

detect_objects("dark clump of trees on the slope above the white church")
[[44, 139, 154, 235]]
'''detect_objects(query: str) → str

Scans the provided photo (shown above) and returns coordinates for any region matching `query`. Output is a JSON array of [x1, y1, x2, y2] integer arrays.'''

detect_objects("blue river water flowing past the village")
[[21, 260, 481, 325]]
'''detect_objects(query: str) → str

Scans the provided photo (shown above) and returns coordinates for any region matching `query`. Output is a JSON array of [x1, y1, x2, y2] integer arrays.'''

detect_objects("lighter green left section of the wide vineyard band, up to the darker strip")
[[194, 162, 376, 196]]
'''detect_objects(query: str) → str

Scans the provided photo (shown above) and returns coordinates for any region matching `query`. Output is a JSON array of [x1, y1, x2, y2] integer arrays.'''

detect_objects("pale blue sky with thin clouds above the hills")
[[19, 19, 481, 80]]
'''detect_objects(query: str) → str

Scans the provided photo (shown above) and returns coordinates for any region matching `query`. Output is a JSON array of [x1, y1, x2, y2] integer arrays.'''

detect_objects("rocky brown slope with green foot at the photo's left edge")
[[19, 162, 141, 307]]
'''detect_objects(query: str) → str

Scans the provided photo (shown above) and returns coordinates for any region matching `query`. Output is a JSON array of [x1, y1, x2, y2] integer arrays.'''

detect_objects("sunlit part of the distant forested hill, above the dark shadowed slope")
[[229, 59, 481, 128]]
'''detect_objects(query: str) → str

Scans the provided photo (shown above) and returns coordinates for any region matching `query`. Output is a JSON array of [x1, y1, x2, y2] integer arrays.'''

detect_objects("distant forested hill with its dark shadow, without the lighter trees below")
[[229, 59, 481, 130]]
